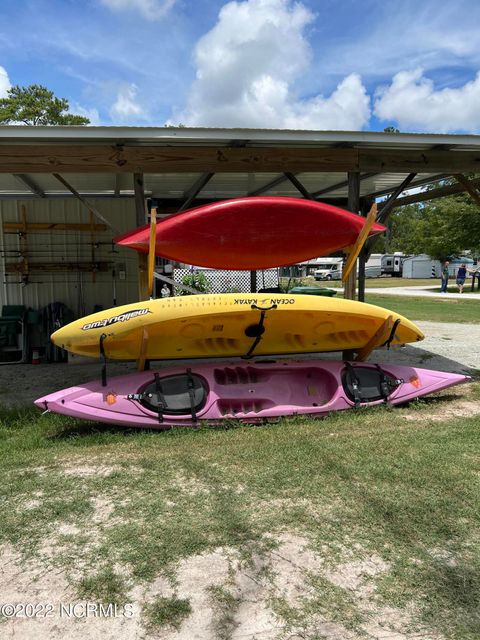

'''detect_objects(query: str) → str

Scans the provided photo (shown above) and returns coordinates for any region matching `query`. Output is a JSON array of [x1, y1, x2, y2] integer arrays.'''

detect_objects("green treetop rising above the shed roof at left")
[[0, 84, 90, 125]]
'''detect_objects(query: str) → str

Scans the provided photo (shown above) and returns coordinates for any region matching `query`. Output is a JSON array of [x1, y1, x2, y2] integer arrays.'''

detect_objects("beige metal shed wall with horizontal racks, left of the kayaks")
[[0, 198, 142, 317]]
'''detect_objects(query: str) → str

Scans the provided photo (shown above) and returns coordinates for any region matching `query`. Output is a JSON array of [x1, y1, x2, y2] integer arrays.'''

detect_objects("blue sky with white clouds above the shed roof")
[[0, 0, 480, 133]]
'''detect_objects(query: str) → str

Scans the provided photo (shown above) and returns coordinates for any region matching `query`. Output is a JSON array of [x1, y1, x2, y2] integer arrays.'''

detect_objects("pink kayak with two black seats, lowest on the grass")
[[35, 360, 470, 428]]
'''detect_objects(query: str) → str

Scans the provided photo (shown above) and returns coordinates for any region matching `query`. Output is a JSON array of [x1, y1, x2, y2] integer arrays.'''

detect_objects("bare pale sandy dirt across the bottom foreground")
[[0, 532, 443, 640]]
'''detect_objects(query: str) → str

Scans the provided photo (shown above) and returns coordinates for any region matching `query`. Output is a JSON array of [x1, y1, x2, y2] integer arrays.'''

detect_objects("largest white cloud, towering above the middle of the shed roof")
[[176, 0, 370, 129]]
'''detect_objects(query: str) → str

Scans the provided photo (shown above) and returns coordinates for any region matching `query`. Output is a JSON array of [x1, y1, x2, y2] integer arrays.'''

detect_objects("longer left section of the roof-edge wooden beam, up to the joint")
[[0, 144, 358, 174]]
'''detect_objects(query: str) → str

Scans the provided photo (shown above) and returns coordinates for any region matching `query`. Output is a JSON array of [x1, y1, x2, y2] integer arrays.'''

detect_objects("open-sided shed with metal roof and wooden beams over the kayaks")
[[0, 126, 480, 314]]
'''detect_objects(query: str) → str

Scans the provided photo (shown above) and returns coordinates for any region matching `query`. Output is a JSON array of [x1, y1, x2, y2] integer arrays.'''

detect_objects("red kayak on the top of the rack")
[[115, 197, 385, 270]]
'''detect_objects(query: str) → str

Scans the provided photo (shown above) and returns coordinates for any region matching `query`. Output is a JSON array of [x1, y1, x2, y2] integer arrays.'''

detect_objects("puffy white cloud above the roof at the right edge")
[[375, 69, 480, 133]]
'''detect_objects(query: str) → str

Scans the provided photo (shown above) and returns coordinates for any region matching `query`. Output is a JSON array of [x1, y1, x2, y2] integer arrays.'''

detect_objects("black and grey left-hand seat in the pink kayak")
[[140, 373, 208, 415]]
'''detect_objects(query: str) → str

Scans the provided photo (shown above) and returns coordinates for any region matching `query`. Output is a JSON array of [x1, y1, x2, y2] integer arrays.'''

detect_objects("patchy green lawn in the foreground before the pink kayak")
[[0, 383, 480, 640]]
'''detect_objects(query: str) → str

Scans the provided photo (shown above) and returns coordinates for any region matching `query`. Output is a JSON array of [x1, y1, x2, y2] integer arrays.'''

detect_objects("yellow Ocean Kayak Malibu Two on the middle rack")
[[51, 293, 424, 360]]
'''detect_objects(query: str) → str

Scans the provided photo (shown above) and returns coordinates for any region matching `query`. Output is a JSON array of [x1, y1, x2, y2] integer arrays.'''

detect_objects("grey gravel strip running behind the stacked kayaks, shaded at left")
[[0, 322, 474, 406]]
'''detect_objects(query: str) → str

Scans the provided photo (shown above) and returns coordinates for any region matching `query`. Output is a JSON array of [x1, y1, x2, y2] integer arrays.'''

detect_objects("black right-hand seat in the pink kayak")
[[342, 365, 399, 402]]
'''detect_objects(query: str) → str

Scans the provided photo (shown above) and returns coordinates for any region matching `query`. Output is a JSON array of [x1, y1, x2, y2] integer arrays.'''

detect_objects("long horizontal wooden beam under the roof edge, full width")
[[0, 143, 480, 174]]
